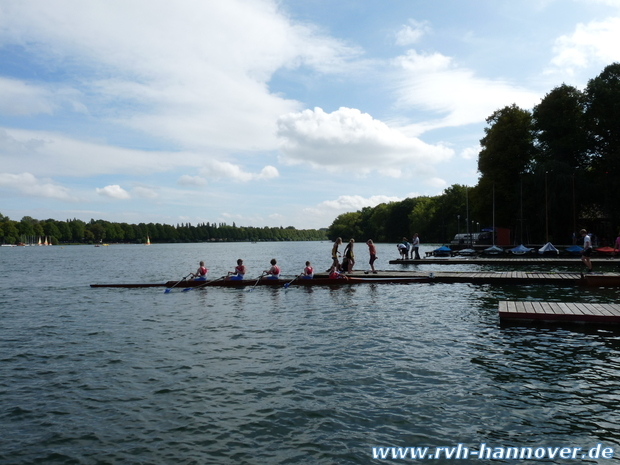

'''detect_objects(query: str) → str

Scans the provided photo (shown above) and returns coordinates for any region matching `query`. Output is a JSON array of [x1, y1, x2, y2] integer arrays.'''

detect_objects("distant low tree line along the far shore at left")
[[0, 214, 326, 245]]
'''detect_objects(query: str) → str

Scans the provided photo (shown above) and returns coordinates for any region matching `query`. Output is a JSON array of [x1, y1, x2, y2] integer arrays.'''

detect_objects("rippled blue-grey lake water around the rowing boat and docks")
[[0, 242, 620, 464]]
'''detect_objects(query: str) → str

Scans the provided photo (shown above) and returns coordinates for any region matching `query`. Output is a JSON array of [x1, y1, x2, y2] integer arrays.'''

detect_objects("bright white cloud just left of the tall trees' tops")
[[393, 50, 540, 134]]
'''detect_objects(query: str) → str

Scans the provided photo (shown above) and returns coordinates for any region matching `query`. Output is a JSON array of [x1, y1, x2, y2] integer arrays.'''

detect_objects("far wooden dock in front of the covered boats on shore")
[[389, 257, 620, 268]]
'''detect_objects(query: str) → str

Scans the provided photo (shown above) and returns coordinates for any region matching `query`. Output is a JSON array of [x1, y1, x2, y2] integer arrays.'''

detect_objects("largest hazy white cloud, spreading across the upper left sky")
[[0, 0, 361, 150]]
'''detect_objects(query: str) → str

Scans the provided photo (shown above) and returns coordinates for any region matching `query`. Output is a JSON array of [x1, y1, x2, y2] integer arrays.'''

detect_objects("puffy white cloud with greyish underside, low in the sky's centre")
[[278, 108, 453, 177]]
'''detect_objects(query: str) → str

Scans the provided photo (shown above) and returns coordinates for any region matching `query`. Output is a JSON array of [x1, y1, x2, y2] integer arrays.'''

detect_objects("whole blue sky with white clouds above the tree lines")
[[0, 0, 620, 229]]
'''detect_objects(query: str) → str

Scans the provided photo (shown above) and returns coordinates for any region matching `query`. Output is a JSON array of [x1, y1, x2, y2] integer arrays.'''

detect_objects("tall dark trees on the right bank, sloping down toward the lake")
[[327, 63, 620, 248]]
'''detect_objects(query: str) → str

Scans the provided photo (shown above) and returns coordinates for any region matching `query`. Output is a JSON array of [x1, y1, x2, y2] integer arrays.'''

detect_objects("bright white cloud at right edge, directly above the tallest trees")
[[551, 17, 620, 74]]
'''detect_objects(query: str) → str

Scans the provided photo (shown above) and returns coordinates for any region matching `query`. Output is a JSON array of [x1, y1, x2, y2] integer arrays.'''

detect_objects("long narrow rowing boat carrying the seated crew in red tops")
[[90, 277, 430, 289]]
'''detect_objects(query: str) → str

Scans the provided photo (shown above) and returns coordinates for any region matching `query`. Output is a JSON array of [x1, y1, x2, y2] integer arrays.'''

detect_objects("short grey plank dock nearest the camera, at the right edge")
[[498, 300, 620, 324]]
